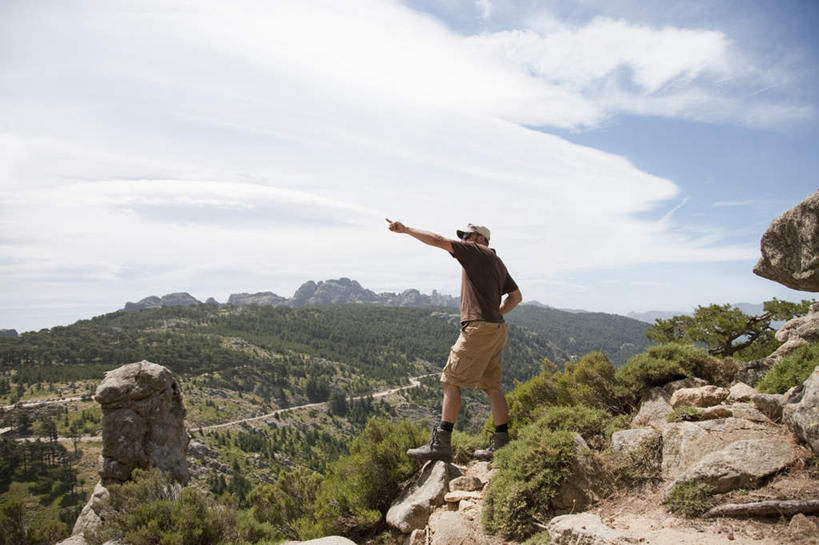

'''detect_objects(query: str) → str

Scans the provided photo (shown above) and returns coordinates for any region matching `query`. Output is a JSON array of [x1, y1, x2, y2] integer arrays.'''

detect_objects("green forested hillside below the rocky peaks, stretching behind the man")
[[0, 304, 647, 397]]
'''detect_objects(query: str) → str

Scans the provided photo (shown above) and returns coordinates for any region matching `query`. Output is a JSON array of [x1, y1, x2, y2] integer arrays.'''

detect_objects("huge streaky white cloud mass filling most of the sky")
[[0, 0, 811, 328]]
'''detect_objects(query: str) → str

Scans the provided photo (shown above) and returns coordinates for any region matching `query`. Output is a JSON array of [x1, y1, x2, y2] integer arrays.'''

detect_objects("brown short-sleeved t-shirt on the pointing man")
[[452, 240, 518, 322]]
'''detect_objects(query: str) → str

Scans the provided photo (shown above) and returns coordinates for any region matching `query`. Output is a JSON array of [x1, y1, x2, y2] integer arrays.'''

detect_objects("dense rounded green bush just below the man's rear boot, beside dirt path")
[[482, 425, 576, 540]]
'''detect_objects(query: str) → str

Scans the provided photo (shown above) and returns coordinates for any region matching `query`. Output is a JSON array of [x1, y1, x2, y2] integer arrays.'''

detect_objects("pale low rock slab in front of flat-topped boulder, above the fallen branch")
[[666, 438, 797, 493]]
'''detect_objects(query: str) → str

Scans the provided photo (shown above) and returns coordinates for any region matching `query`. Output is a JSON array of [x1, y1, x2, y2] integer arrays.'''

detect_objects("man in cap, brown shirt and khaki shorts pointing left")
[[387, 219, 522, 462]]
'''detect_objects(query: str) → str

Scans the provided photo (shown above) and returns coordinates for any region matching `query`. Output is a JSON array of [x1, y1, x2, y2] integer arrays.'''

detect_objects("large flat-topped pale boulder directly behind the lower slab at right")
[[662, 417, 788, 479]]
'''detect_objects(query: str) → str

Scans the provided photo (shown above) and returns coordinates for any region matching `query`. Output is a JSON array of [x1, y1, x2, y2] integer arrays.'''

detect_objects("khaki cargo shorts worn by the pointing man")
[[441, 321, 506, 390]]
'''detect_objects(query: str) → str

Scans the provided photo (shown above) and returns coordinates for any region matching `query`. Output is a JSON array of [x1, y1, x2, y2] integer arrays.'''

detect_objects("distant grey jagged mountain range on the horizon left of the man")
[[124, 278, 459, 312]]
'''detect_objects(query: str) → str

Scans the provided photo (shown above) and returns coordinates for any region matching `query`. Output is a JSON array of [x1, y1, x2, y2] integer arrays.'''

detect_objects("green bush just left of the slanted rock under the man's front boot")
[[308, 418, 427, 539]]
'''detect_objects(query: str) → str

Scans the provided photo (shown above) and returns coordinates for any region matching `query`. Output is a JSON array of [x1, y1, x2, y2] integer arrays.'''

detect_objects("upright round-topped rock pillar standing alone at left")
[[94, 361, 189, 485]]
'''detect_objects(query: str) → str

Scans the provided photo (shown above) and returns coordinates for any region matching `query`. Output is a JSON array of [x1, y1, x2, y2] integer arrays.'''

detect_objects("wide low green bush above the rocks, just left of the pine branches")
[[615, 343, 736, 401]]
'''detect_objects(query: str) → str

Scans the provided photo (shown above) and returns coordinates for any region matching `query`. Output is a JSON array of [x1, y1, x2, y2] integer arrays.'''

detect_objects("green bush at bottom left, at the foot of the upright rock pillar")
[[86, 469, 236, 545]]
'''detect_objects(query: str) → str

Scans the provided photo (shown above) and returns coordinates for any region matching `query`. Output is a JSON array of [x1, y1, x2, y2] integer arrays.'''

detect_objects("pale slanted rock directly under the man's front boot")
[[387, 461, 460, 534]]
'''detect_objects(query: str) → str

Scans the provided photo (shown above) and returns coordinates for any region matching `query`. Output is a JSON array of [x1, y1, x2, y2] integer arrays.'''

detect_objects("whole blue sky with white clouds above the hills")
[[0, 0, 819, 331]]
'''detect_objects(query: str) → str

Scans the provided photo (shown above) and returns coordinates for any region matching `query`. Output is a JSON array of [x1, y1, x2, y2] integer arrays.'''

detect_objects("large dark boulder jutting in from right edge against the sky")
[[754, 191, 819, 291]]
